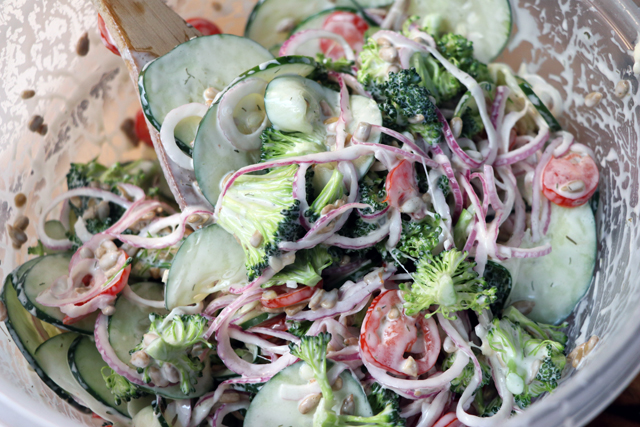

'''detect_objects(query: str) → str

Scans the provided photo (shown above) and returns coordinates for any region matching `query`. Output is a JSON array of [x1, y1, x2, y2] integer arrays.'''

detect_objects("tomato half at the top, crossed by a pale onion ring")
[[320, 12, 369, 59]]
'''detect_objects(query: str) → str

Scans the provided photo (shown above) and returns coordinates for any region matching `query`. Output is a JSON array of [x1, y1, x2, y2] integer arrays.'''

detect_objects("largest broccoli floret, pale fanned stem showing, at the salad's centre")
[[218, 165, 303, 280]]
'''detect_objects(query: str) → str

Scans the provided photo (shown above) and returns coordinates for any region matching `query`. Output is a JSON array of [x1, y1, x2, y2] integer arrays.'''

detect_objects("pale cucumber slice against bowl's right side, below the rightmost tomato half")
[[503, 203, 597, 324]]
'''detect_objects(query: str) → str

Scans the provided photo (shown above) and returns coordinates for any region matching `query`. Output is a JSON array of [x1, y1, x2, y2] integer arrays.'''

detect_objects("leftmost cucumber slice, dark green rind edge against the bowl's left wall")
[[2, 270, 90, 413]]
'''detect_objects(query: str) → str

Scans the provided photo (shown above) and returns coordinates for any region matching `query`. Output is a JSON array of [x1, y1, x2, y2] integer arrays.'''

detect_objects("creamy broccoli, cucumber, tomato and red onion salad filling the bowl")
[[0, 0, 599, 427]]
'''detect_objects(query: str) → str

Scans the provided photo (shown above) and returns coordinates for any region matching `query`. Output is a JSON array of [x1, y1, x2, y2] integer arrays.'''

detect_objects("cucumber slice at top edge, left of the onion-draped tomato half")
[[244, 0, 353, 48]]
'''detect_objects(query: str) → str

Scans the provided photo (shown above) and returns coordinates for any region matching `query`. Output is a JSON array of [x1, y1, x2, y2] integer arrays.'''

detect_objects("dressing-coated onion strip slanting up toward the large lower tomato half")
[[289, 269, 394, 320]]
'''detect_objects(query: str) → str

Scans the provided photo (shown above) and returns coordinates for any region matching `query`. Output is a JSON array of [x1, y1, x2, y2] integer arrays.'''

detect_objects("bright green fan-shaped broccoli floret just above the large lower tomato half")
[[401, 249, 495, 318]]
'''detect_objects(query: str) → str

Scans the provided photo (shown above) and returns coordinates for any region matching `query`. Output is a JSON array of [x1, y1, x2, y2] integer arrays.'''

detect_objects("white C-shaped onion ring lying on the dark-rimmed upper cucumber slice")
[[218, 77, 267, 151]]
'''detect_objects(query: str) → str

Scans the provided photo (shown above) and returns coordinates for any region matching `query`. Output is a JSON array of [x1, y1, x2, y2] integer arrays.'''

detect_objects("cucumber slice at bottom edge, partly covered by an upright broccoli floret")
[[244, 361, 373, 427]]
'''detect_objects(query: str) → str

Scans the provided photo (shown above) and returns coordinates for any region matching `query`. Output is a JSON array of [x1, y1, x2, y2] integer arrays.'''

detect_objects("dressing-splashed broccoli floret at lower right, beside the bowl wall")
[[483, 309, 566, 408]]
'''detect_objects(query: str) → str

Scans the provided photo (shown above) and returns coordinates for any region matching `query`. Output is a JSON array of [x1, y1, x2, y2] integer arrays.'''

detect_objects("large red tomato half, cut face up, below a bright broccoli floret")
[[360, 290, 441, 376]]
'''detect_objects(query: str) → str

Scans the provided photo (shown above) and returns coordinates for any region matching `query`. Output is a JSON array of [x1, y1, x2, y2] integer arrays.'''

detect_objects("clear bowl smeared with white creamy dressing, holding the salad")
[[0, 0, 640, 427]]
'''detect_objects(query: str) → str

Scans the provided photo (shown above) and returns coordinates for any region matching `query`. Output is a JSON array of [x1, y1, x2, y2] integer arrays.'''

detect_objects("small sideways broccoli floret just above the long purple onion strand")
[[260, 126, 327, 162]]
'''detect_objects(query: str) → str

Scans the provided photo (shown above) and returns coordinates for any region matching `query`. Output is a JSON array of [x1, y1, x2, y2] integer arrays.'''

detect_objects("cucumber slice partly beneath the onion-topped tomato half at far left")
[[15, 253, 98, 335]]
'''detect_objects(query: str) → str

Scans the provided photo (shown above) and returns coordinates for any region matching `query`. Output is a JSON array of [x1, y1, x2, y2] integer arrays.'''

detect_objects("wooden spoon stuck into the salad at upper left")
[[92, 0, 211, 209]]
